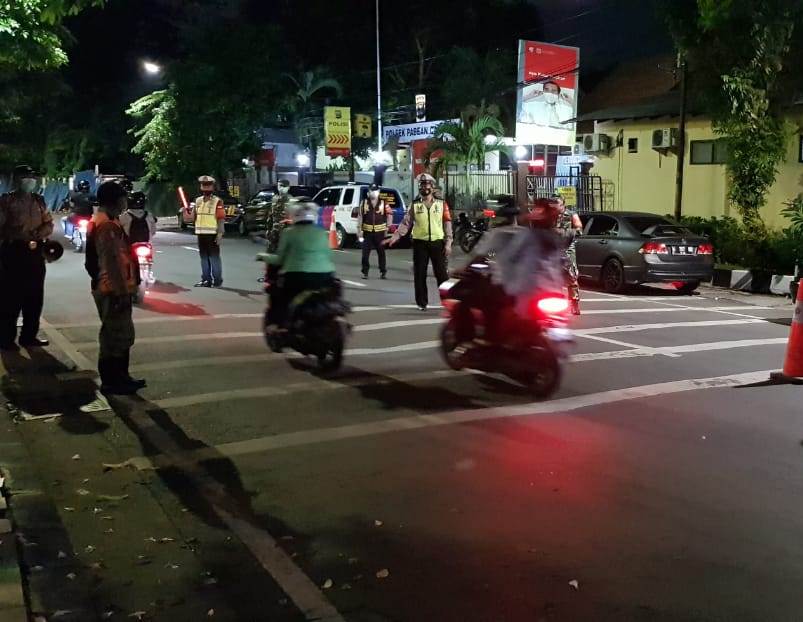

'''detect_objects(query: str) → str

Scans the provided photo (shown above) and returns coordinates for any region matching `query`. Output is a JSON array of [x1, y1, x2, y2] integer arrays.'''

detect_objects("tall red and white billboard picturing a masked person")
[[516, 41, 580, 147]]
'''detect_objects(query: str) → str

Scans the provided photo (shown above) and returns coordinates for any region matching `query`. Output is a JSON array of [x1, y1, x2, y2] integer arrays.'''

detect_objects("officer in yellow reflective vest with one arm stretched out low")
[[388, 173, 452, 311]]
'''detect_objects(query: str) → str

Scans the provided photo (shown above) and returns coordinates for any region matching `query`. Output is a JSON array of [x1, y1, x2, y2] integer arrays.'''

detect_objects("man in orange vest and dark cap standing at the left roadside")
[[85, 181, 146, 395]]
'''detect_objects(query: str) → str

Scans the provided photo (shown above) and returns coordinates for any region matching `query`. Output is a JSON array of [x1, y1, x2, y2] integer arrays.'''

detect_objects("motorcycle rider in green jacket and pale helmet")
[[257, 202, 335, 329]]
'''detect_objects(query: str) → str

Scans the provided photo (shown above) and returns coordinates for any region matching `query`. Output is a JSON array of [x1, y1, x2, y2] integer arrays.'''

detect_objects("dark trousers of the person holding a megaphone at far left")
[[0, 242, 45, 344]]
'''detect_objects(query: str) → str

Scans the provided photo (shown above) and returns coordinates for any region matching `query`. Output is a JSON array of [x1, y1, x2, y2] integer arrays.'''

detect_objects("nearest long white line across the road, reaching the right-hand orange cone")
[[132, 370, 774, 468]]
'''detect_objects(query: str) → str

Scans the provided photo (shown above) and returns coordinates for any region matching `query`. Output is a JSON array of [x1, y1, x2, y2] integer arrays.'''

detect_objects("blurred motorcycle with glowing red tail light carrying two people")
[[439, 262, 574, 399]]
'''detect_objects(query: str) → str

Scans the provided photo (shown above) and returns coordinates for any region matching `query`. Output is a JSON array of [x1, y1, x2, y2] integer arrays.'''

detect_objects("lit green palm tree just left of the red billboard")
[[426, 111, 504, 207]]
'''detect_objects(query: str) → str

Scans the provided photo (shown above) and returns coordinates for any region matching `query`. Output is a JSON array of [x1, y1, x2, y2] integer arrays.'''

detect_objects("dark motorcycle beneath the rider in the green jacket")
[[264, 280, 351, 372]]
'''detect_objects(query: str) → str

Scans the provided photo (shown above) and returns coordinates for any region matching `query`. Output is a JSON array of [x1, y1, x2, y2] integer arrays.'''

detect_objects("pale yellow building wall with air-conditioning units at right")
[[592, 115, 803, 227]]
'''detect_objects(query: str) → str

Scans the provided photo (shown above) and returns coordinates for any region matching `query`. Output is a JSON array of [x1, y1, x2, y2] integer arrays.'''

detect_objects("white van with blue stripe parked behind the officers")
[[312, 183, 406, 248]]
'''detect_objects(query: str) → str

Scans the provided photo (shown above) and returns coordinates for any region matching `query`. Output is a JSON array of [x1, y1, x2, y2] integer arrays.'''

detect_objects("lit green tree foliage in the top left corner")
[[0, 0, 105, 70]]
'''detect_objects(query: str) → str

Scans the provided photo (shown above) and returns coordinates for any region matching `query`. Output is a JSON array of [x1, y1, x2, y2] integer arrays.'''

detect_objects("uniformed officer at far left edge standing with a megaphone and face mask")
[[0, 165, 53, 351]]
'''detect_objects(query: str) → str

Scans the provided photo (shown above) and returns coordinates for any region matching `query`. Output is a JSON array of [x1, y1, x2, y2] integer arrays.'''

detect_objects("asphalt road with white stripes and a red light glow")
[[0, 224, 803, 622]]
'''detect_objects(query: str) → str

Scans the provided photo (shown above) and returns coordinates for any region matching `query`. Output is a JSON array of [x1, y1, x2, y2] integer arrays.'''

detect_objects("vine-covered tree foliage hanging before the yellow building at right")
[[664, 0, 803, 237]]
